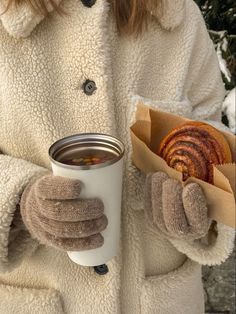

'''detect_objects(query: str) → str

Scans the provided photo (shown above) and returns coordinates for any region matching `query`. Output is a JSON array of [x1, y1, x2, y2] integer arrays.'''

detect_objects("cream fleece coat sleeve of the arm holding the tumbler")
[[0, 152, 46, 272]]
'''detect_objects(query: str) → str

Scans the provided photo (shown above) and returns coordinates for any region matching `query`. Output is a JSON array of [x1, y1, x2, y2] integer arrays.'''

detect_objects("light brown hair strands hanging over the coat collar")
[[3, 0, 161, 34]]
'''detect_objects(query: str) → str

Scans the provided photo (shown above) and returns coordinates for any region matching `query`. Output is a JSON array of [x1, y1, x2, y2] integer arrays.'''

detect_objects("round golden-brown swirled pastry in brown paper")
[[159, 122, 232, 183]]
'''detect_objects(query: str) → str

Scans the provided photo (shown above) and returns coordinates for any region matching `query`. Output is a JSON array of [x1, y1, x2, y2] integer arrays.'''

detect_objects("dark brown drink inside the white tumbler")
[[60, 149, 117, 166]]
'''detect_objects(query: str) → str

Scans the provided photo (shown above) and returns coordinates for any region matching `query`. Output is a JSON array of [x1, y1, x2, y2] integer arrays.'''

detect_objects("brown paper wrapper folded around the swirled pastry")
[[131, 102, 236, 228]]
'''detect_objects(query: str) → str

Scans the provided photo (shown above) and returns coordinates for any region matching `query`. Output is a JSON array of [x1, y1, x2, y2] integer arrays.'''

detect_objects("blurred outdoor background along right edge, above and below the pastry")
[[195, 0, 236, 314]]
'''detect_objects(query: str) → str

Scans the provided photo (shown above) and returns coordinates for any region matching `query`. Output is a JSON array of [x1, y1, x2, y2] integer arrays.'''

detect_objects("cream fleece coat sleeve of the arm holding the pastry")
[[170, 0, 235, 265]]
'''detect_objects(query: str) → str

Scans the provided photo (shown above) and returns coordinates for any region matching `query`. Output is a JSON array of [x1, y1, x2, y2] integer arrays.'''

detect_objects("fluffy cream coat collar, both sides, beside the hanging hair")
[[0, 0, 186, 38]]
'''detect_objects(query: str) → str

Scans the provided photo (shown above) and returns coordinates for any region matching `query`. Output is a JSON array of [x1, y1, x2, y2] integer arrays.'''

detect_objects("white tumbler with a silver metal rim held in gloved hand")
[[49, 133, 124, 266]]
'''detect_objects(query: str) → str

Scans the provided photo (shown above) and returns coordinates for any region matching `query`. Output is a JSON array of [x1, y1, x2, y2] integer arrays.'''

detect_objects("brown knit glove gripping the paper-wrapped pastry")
[[145, 172, 210, 239]]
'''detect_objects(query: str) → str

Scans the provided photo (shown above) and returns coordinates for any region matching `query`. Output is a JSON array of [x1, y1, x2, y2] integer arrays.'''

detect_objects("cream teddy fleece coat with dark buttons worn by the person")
[[0, 0, 234, 314]]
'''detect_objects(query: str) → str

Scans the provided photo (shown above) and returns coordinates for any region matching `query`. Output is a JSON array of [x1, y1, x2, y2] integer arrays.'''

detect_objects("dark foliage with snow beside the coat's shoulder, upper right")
[[195, 0, 236, 134]]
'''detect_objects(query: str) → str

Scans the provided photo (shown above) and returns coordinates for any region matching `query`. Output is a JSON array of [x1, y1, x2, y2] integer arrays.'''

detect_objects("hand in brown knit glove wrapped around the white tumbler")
[[20, 174, 108, 251]]
